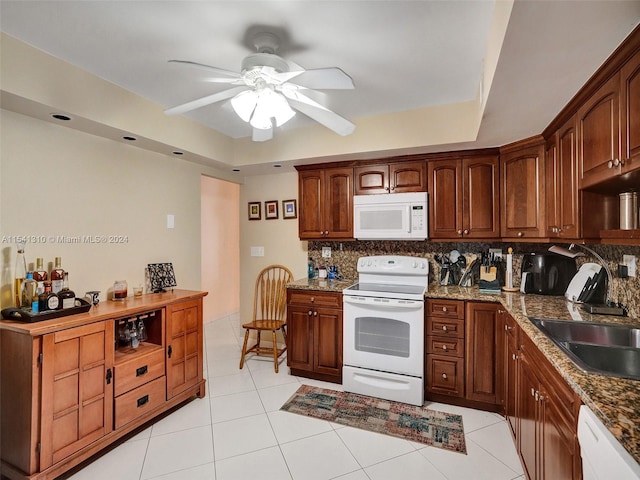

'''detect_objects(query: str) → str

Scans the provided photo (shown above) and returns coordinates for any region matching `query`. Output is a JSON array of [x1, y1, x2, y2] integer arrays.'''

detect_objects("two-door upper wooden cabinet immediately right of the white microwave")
[[427, 155, 500, 240]]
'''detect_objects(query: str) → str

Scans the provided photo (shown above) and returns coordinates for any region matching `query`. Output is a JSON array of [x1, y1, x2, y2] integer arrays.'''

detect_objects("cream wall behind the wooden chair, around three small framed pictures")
[[240, 172, 307, 320]]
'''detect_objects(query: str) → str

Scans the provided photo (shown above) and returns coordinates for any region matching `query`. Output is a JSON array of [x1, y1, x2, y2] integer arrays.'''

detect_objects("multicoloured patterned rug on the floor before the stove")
[[280, 385, 467, 454]]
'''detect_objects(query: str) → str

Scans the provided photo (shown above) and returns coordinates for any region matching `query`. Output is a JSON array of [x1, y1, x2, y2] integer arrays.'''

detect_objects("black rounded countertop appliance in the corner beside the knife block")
[[520, 253, 577, 295]]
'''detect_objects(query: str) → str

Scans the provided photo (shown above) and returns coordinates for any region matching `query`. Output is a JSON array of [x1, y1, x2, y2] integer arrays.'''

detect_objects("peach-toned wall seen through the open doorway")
[[200, 175, 240, 322]]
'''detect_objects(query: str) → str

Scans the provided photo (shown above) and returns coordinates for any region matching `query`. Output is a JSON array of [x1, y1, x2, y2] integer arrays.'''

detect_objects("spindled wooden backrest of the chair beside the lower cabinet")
[[253, 265, 293, 320]]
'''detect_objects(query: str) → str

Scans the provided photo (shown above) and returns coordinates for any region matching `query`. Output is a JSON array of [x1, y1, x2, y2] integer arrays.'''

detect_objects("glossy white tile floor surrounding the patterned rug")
[[69, 316, 524, 480]]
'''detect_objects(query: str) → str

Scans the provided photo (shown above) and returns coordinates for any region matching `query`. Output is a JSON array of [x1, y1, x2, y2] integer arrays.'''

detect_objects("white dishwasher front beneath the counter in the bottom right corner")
[[578, 405, 640, 480]]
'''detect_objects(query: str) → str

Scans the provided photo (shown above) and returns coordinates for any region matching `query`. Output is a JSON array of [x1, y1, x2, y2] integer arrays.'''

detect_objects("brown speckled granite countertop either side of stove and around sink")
[[288, 279, 640, 463]]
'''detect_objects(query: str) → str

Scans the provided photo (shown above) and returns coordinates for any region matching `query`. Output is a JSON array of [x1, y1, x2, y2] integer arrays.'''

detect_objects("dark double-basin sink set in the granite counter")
[[531, 318, 640, 380]]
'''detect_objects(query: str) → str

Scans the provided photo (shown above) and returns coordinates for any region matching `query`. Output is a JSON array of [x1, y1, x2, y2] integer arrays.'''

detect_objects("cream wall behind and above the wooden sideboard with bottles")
[[0, 110, 229, 307]]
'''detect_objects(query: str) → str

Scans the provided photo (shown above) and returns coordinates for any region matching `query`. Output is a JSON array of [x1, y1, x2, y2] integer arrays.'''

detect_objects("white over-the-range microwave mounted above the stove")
[[353, 192, 429, 240]]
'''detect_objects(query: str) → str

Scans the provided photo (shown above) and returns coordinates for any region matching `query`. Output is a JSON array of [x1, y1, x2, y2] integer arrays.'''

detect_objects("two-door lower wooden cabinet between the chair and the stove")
[[287, 289, 342, 383]]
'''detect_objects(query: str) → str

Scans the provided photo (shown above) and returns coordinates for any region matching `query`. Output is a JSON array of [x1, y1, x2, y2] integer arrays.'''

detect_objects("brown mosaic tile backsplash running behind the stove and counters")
[[309, 240, 640, 318]]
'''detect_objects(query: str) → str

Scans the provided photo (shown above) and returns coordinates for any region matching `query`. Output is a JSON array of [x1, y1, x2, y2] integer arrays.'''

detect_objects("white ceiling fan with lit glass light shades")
[[165, 32, 355, 141]]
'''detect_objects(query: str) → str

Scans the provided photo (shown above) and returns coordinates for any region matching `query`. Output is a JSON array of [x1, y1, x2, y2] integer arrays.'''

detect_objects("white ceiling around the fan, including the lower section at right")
[[0, 0, 640, 167]]
